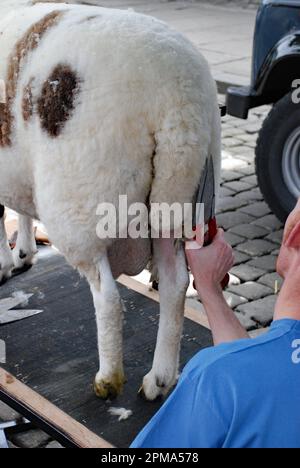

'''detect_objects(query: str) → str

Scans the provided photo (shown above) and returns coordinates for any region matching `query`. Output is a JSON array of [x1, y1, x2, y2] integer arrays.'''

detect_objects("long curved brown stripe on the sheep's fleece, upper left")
[[0, 10, 64, 146]]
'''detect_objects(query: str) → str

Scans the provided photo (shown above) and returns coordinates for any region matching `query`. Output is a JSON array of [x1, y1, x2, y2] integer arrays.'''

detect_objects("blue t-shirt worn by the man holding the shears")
[[132, 319, 300, 448]]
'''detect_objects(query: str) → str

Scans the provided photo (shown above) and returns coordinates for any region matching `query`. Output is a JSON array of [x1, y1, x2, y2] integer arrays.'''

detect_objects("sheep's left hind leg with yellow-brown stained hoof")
[[91, 256, 125, 399]]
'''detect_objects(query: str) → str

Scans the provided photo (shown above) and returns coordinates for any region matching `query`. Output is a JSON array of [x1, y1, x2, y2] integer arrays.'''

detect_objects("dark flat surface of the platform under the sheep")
[[0, 249, 212, 447]]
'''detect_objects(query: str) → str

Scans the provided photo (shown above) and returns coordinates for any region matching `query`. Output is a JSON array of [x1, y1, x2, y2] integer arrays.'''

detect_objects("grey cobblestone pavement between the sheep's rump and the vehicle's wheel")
[[190, 103, 283, 331]]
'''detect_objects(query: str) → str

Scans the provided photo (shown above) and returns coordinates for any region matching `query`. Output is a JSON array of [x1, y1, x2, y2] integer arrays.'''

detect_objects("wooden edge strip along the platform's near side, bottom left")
[[0, 367, 113, 449]]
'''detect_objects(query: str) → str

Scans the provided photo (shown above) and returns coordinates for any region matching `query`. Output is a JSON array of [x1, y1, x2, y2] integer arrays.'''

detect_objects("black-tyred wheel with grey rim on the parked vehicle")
[[256, 94, 300, 222]]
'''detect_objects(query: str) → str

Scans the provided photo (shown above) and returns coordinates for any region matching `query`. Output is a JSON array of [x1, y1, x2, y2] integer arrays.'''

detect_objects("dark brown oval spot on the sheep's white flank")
[[38, 64, 80, 137]]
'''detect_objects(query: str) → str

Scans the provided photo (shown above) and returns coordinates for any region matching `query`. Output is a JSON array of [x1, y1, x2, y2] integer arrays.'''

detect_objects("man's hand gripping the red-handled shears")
[[186, 229, 234, 297]]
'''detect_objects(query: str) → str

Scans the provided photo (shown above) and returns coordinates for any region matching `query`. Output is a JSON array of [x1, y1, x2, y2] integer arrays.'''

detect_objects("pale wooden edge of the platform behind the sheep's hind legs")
[[118, 275, 211, 330]]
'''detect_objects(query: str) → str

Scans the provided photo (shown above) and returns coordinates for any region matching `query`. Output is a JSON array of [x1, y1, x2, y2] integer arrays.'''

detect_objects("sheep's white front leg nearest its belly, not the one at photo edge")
[[13, 215, 37, 269]]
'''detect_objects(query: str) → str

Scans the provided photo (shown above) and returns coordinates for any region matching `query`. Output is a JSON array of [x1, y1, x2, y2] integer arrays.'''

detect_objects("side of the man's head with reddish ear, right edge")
[[277, 199, 300, 278]]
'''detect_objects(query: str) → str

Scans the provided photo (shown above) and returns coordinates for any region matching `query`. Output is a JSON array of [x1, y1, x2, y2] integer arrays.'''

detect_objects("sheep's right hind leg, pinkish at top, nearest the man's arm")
[[142, 239, 189, 400]]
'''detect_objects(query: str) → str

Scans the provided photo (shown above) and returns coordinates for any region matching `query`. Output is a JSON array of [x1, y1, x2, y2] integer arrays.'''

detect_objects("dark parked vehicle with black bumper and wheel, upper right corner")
[[227, 0, 300, 221]]
